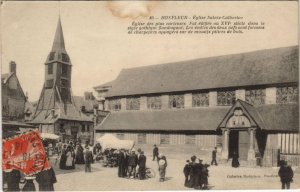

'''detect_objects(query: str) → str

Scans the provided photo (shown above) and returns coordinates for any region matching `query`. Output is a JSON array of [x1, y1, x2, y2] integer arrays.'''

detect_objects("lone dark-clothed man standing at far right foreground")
[[278, 161, 294, 189]]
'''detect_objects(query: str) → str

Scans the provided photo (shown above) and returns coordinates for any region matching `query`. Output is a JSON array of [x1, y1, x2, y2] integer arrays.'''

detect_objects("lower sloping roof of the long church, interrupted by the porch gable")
[[95, 103, 299, 131]]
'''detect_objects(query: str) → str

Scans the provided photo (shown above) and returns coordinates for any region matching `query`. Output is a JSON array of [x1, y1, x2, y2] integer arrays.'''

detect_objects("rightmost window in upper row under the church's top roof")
[[276, 86, 299, 103]]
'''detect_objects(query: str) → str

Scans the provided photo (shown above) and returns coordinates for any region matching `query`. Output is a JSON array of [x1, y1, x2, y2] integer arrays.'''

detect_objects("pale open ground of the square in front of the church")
[[43, 146, 300, 191]]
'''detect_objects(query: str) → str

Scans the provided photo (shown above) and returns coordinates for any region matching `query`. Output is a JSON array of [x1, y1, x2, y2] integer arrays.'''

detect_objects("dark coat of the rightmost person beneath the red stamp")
[[36, 167, 57, 191]]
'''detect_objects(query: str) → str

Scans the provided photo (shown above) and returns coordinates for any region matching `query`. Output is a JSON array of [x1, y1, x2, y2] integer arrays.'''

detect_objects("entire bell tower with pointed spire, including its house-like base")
[[31, 19, 94, 143]]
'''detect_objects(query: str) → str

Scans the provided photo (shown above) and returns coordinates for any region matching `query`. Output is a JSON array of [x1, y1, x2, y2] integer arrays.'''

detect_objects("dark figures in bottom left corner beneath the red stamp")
[[3, 167, 57, 191]]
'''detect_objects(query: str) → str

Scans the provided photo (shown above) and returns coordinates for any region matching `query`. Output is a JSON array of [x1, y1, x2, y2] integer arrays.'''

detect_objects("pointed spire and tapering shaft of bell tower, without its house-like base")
[[33, 18, 74, 111]]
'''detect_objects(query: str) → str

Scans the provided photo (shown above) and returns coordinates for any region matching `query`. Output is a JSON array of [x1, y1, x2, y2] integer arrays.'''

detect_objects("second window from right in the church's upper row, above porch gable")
[[245, 89, 266, 105]]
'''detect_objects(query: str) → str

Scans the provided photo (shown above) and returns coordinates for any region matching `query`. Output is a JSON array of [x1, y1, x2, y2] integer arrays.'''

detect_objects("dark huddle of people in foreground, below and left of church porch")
[[183, 156, 209, 189]]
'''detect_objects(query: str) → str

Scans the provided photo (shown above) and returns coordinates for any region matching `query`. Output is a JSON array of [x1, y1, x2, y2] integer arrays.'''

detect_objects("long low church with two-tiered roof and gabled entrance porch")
[[95, 46, 300, 166]]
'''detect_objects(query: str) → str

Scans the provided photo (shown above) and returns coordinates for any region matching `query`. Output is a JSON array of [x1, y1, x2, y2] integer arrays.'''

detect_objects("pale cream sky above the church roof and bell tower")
[[1, 1, 298, 101]]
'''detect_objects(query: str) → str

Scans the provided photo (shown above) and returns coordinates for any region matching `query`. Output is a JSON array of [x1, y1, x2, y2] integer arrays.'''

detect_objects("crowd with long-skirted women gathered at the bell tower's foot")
[[58, 142, 101, 172]]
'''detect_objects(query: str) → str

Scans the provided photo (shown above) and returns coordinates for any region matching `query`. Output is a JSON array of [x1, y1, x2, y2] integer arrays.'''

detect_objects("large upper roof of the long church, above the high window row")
[[106, 46, 299, 97]]
